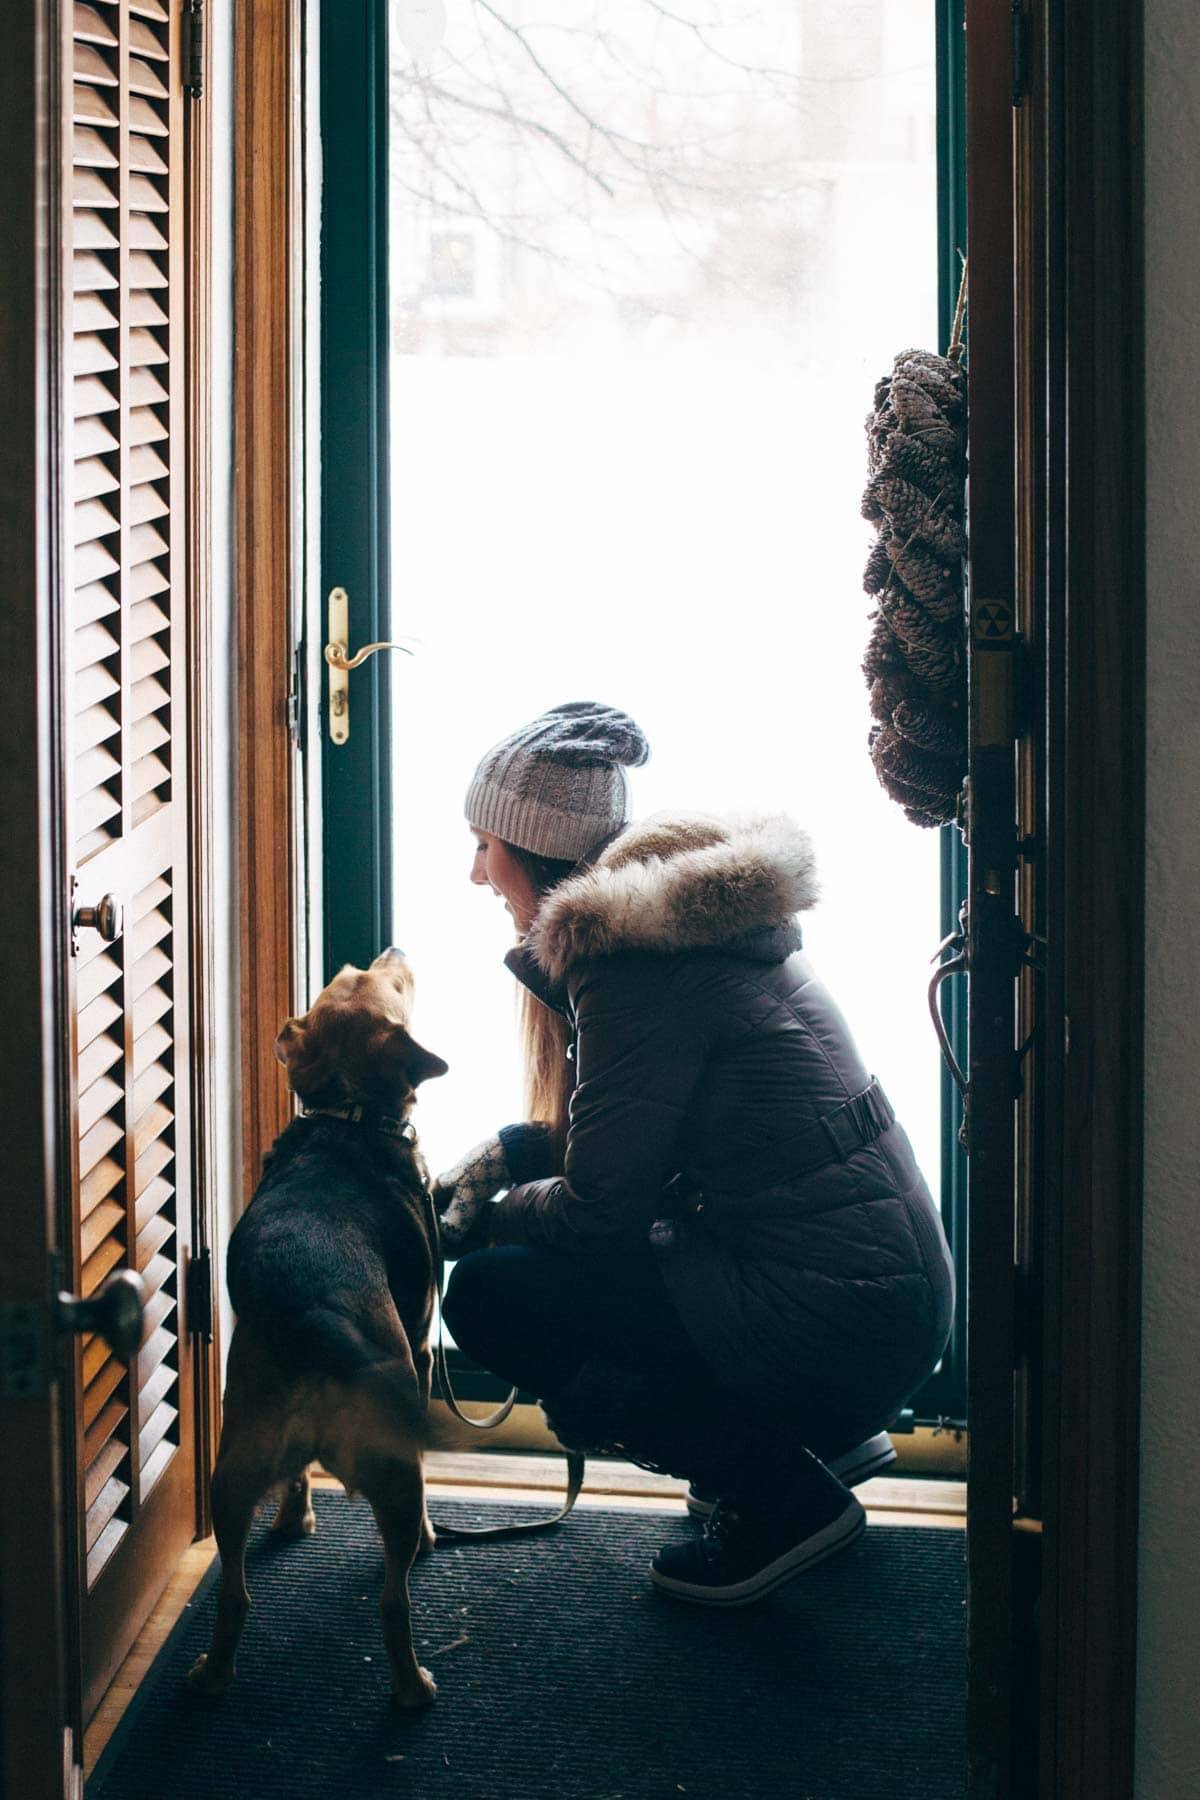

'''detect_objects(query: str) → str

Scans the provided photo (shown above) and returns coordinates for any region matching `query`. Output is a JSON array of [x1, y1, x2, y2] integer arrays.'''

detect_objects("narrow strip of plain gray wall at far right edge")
[[1137, 0, 1200, 1800]]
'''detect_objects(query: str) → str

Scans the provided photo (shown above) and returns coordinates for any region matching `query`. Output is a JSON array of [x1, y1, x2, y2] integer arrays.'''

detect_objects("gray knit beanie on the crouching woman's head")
[[466, 700, 649, 862]]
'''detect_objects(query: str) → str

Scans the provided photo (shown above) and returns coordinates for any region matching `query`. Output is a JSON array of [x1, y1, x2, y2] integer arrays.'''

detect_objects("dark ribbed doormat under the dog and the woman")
[[88, 1490, 966, 1800]]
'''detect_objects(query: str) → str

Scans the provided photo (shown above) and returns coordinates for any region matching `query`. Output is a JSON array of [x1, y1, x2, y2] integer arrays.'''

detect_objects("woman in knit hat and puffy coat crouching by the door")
[[435, 702, 954, 1606]]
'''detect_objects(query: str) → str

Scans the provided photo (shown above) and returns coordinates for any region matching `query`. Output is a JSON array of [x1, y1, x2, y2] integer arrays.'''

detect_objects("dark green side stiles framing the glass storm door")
[[322, 0, 966, 1426]]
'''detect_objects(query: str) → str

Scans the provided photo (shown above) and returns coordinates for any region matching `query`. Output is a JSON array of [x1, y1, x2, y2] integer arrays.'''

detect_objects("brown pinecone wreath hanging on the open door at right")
[[862, 324, 966, 824]]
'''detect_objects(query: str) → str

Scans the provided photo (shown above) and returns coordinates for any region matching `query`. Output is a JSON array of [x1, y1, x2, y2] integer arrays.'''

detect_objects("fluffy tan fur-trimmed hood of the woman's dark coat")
[[525, 814, 819, 981]]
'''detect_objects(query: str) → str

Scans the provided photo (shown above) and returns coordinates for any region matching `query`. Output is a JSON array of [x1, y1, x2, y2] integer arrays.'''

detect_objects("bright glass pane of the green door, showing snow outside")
[[390, 0, 939, 1186]]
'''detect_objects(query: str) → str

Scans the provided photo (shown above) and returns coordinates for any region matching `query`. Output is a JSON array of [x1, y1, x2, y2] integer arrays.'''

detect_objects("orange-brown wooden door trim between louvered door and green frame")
[[234, 0, 304, 1204]]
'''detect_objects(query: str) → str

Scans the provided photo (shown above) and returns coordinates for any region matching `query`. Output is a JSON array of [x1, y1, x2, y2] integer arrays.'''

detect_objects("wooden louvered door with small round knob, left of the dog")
[[67, 0, 194, 1699]]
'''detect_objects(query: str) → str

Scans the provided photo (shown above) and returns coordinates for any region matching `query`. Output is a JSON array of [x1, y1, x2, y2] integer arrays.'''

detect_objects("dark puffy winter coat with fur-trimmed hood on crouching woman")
[[493, 817, 954, 1442]]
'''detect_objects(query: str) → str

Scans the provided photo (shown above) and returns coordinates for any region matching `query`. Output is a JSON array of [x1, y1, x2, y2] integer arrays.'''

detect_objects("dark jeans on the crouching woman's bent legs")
[[443, 1244, 729, 1404]]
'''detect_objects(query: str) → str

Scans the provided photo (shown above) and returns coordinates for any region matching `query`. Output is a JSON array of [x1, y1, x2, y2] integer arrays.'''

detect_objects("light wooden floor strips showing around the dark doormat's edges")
[[83, 1451, 966, 1777]]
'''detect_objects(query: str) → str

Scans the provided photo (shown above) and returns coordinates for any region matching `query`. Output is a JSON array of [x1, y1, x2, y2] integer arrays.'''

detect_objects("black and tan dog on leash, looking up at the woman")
[[187, 949, 446, 1708]]
